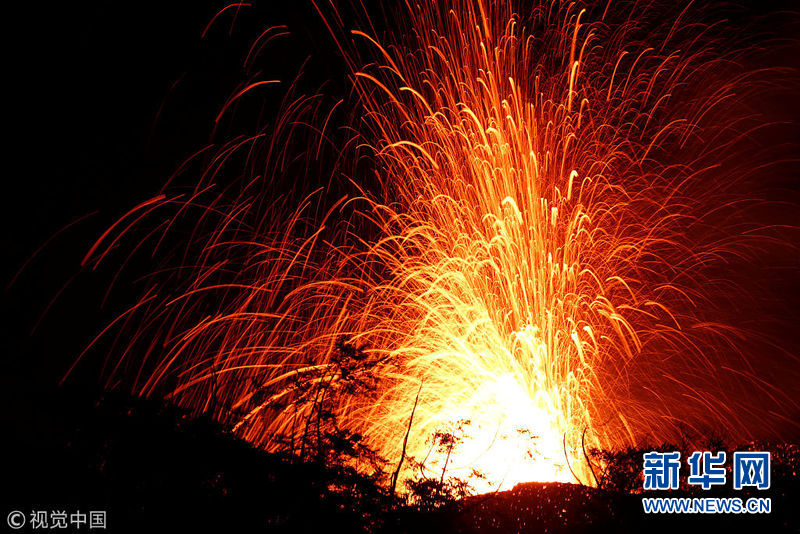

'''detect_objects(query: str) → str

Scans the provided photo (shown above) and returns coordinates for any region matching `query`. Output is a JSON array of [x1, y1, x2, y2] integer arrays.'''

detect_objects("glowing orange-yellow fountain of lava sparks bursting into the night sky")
[[72, 0, 793, 491]]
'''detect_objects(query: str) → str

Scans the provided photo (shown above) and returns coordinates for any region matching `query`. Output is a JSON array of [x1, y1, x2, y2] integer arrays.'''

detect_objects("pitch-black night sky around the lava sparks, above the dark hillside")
[[0, 0, 800, 528]]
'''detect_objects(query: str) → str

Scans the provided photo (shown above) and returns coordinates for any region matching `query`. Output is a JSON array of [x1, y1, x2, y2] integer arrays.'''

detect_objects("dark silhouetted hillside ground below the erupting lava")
[[3, 392, 800, 534]]
